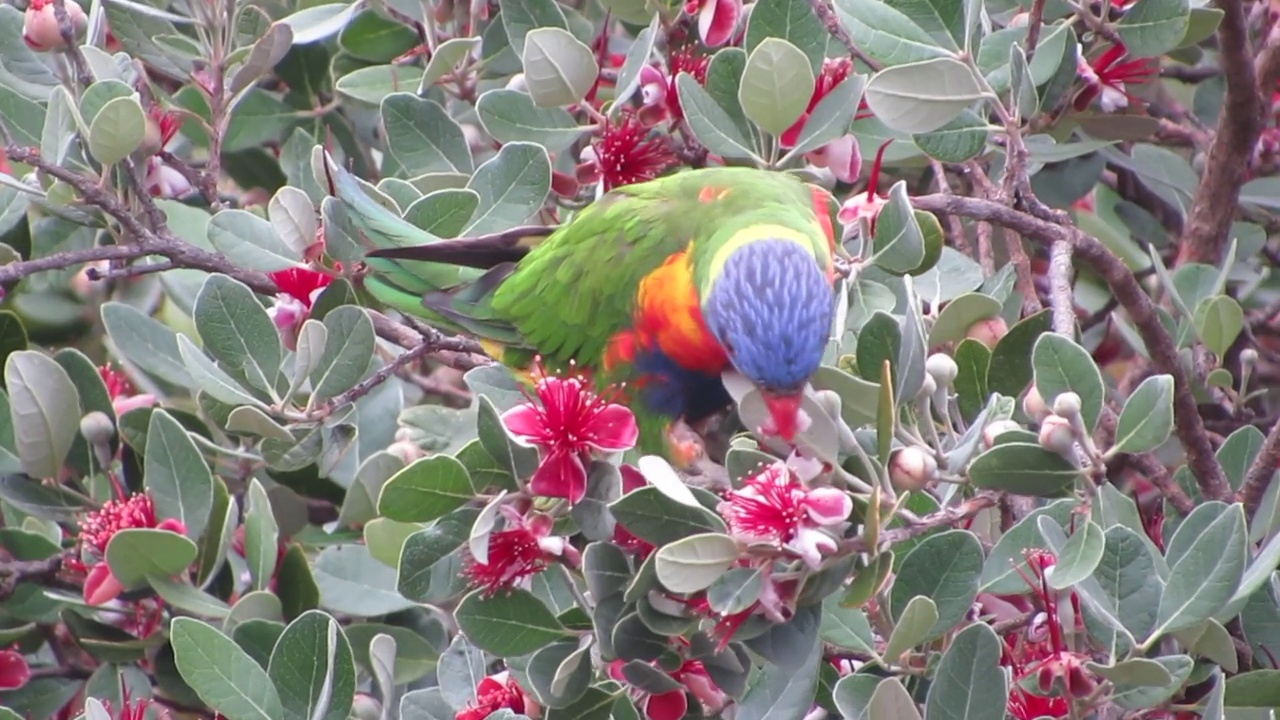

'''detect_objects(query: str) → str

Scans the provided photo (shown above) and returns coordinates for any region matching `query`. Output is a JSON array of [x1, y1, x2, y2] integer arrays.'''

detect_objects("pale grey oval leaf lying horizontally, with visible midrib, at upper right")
[[867, 58, 983, 133]]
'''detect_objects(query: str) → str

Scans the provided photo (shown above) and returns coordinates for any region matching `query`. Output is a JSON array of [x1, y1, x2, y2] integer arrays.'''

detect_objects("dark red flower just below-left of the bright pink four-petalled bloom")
[[462, 505, 577, 596]]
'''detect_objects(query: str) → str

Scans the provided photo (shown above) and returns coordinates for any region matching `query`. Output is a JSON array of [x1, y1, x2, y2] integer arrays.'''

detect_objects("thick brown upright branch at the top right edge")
[[1178, 0, 1277, 265]]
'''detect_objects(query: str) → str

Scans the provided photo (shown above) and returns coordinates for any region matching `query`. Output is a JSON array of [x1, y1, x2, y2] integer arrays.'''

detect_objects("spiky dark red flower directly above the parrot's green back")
[[580, 111, 678, 192]]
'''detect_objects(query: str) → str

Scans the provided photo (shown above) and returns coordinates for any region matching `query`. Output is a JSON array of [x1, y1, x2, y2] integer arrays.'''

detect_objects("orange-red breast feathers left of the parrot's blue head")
[[636, 251, 728, 373]]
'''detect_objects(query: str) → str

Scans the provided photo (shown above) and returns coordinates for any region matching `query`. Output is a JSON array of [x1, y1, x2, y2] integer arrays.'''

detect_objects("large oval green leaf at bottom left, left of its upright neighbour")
[[172, 609, 285, 720]]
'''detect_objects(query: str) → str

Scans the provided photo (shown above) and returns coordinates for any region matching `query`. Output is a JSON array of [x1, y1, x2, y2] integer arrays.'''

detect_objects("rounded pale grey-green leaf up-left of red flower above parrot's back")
[[521, 27, 600, 108]]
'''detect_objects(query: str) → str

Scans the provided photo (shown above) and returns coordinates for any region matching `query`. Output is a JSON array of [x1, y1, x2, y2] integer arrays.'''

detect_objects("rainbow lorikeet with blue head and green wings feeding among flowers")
[[334, 168, 838, 460]]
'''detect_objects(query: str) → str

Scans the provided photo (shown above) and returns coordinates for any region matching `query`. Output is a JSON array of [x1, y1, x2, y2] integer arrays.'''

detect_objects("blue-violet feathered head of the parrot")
[[703, 238, 835, 393]]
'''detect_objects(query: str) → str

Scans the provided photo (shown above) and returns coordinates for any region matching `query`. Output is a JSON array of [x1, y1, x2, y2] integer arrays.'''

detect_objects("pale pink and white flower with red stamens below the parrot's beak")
[[719, 461, 854, 569]]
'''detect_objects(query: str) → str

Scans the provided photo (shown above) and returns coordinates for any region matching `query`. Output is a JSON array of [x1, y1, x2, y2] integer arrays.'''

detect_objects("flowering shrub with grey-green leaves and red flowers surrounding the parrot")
[[0, 0, 1280, 720]]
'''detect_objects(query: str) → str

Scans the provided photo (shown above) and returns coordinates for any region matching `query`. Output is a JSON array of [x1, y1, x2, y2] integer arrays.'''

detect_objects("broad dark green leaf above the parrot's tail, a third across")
[[381, 92, 474, 176]]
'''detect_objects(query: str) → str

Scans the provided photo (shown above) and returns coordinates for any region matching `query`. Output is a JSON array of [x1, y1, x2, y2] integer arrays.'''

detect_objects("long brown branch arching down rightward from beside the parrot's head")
[[911, 195, 1231, 500]]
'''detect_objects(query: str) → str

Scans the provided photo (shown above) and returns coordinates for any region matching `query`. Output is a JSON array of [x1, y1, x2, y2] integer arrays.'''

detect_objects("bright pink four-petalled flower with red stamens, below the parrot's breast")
[[502, 365, 640, 503]]
